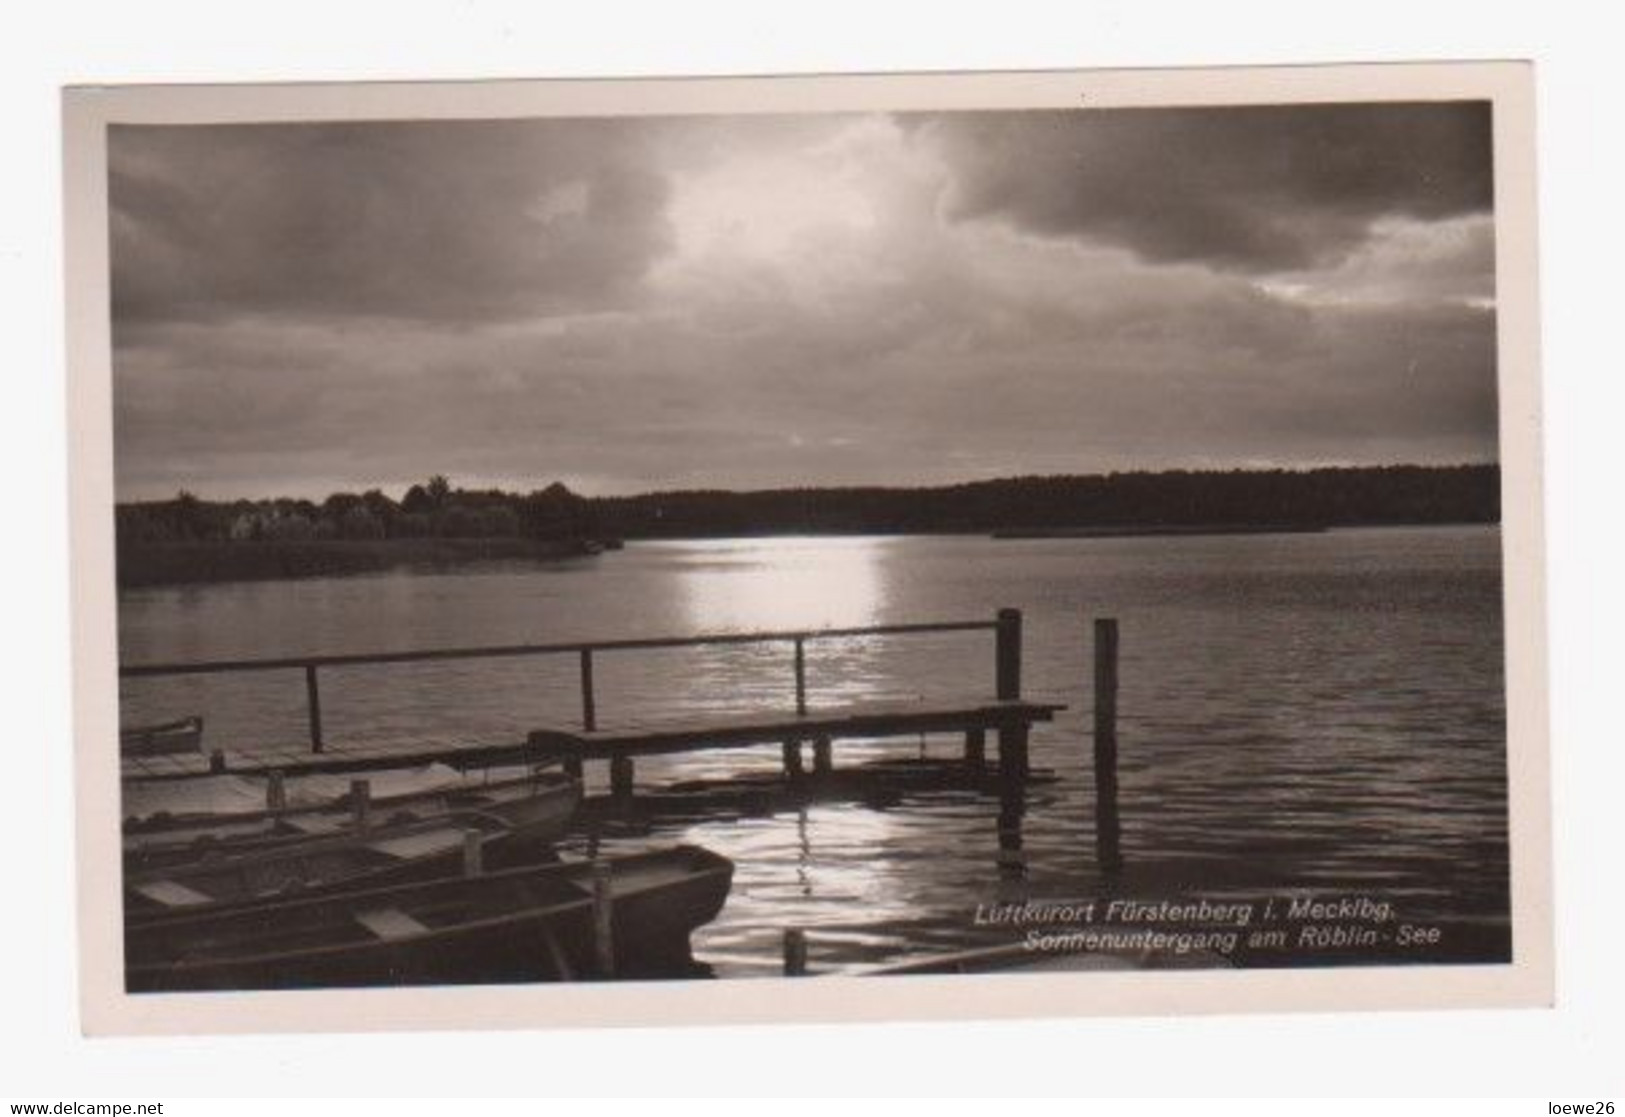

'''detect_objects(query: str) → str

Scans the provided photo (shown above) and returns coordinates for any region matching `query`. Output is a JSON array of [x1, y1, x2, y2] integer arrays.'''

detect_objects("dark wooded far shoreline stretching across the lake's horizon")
[[117, 465, 1500, 543]]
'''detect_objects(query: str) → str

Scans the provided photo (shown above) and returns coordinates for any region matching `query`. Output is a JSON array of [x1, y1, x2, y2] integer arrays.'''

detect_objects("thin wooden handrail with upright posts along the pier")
[[119, 608, 1022, 753]]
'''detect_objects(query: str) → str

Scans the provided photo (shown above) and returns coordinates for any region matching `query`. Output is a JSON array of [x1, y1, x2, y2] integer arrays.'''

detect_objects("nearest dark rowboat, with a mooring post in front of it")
[[125, 845, 733, 993]]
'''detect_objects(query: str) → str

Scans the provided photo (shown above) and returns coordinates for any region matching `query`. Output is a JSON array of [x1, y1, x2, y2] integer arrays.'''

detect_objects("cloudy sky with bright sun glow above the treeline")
[[109, 104, 1495, 498]]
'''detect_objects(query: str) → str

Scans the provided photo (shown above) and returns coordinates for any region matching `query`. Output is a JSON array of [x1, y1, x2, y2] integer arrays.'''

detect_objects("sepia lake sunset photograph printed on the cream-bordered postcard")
[[70, 67, 1549, 1024]]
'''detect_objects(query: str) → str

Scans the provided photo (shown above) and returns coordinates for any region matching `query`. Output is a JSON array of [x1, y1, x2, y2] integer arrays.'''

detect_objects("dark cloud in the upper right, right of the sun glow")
[[926, 102, 1492, 273]]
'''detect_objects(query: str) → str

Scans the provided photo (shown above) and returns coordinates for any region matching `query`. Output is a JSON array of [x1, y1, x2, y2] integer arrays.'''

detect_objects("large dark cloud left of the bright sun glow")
[[109, 120, 670, 322]]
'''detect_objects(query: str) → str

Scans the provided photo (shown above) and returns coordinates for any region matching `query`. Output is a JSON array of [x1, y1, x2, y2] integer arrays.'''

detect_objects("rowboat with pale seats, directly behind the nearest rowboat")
[[124, 811, 554, 922]]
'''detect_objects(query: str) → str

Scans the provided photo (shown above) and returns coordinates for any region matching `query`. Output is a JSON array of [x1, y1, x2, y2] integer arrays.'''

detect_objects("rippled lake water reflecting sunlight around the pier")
[[119, 527, 1510, 976]]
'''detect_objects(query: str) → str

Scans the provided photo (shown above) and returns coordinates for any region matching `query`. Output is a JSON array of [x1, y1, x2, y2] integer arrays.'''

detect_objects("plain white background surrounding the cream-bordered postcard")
[[0, 0, 1625, 1112]]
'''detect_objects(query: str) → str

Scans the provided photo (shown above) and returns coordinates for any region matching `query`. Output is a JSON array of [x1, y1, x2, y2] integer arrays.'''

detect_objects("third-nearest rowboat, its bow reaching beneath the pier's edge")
[[124, 772, 582, 876]]
